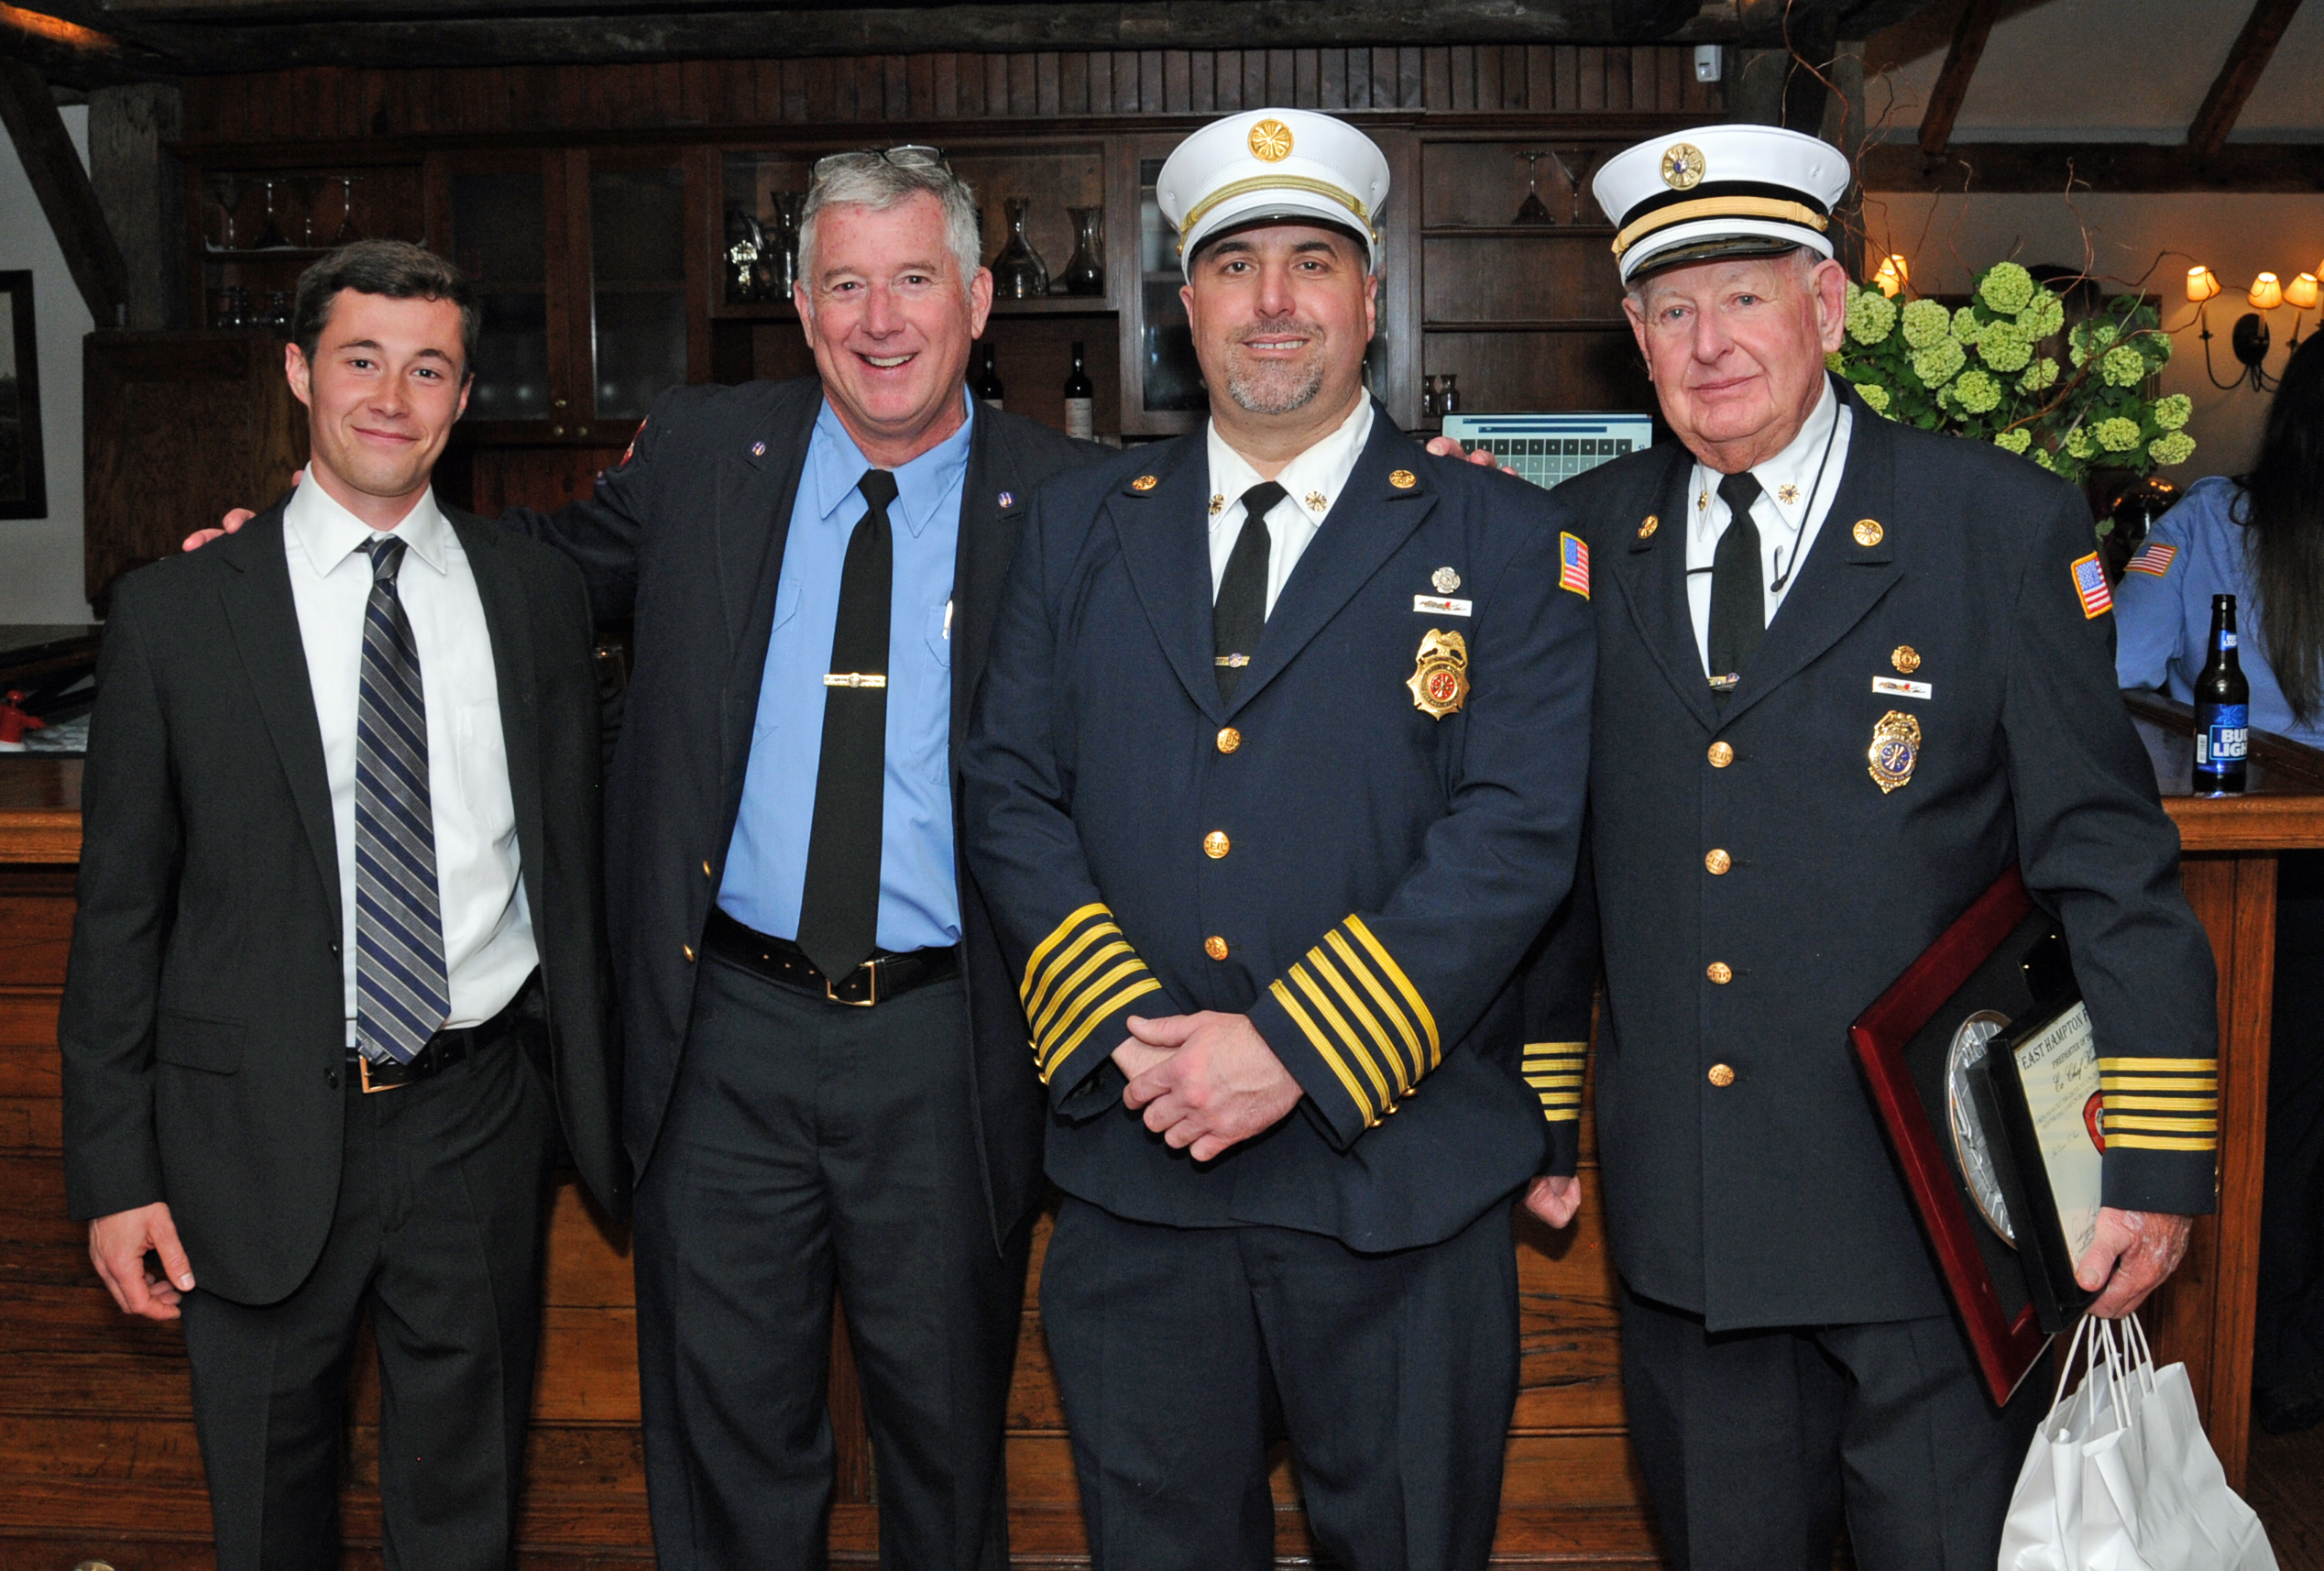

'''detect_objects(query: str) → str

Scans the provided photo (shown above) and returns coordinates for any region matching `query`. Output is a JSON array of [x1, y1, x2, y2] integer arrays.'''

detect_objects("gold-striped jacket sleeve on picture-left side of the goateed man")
[[962, 493, 1180, 1115]]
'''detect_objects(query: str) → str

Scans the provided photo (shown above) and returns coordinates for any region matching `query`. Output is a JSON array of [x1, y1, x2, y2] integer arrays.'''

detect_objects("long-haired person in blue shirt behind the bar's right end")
[[2115, 335, 2324, 1434]]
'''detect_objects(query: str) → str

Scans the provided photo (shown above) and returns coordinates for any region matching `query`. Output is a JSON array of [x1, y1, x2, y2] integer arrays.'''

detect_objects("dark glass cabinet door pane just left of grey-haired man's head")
[[588, 168, 685, 421]]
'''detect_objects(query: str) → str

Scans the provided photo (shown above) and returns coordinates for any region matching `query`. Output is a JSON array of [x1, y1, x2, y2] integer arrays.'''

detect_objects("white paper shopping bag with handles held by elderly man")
[[1999, 1315, 2275, 1571]]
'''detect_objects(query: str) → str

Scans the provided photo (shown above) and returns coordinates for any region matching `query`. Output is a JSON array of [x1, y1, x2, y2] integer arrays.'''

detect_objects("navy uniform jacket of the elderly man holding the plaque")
[[1555, 383, 2217, 1329]]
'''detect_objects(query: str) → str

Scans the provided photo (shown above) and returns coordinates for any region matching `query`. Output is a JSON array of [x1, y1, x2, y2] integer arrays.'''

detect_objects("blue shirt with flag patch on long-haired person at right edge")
[[2115, 474, 2324, 746]]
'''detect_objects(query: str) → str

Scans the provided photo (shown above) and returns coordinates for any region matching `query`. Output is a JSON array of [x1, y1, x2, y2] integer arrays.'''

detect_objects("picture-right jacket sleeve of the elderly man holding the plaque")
[[2001, 488, 2220, 1215]]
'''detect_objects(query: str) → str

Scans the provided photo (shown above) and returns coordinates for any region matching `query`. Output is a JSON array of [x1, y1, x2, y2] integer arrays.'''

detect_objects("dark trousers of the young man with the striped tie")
[[183, 1041, 555, 1571]]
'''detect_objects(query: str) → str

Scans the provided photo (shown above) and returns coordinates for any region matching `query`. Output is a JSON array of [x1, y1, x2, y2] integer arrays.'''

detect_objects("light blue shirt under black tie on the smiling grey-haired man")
[[718, 400, 976, 950]]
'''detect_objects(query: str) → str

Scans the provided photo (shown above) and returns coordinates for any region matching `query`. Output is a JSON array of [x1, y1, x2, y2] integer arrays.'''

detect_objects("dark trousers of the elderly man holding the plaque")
[[1622, 1290, 2050, 1571]]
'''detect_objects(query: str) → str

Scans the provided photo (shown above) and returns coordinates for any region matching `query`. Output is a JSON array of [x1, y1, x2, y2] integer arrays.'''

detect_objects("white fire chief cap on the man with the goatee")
[[1155, 109, 1387, 269]]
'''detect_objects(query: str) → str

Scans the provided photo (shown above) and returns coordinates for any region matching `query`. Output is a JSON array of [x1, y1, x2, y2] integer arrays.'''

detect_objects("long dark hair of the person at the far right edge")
[[2233, 333, 2324, 725]]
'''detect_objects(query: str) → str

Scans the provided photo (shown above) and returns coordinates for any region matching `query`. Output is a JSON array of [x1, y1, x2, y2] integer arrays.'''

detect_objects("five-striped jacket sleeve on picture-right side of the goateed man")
[[1250, 504, 1596, 1148]]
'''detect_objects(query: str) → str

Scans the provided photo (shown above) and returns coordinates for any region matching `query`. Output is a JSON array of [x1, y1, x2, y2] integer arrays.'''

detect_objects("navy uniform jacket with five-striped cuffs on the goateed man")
[[962, 412, 1592, 1250]]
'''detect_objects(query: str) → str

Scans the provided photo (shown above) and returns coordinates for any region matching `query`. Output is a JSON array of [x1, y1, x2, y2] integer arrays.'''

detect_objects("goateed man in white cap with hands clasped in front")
[[964, 109, 1590, 1571]]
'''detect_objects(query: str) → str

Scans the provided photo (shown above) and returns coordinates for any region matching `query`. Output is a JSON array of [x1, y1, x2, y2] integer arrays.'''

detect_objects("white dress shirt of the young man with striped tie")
[[283, 477, 539, 1046]]
